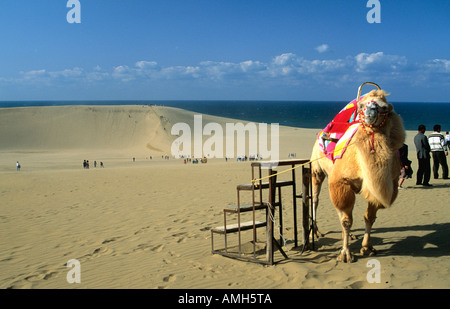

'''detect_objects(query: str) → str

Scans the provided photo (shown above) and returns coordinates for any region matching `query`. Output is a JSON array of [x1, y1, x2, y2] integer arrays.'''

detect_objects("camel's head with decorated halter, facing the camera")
[[358, 90, 394, 128]]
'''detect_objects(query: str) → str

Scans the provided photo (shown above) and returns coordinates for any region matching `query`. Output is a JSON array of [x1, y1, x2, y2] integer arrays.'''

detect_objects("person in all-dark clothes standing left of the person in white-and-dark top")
[[414, 124, 431, 187]]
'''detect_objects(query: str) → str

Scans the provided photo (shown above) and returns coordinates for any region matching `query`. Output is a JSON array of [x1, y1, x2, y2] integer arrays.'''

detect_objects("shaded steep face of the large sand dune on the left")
[[0, 106, 174, 152]]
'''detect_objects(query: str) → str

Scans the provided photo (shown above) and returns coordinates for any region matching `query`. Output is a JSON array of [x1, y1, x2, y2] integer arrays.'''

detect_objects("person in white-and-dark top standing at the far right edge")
[[428, 124, 448, 179]]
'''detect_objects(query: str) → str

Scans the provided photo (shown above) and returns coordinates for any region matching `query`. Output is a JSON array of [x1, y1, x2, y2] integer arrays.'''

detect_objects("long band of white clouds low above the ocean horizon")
[[4, 52, 450, 96]]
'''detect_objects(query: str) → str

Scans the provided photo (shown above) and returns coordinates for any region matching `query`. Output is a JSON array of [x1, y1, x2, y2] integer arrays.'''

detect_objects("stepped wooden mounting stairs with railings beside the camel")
[[211, 160, 310, 265]]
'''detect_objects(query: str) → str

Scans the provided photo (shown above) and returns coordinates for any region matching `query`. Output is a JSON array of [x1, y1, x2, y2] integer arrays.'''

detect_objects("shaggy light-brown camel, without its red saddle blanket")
[[311, 83, 405, 263]]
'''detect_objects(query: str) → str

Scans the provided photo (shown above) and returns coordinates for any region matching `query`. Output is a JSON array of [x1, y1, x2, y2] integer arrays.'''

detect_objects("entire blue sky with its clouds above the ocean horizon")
[[0, 0, 450, 102]]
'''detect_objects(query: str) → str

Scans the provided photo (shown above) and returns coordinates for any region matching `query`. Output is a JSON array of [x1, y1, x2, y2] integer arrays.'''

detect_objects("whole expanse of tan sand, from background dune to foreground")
[[0, 106, 450, 289]]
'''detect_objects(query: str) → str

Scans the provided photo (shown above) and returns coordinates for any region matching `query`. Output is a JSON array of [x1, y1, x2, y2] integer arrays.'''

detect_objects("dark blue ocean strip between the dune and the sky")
[[0, 100, 450, 132]]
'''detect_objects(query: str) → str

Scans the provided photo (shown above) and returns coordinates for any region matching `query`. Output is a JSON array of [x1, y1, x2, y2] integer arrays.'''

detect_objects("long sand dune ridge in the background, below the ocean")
[[0, 105, 317, 157]]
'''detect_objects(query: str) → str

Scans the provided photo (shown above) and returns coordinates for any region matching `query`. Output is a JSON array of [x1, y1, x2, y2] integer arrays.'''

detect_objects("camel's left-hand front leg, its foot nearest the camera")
[[330, 182, 355, 263]]
